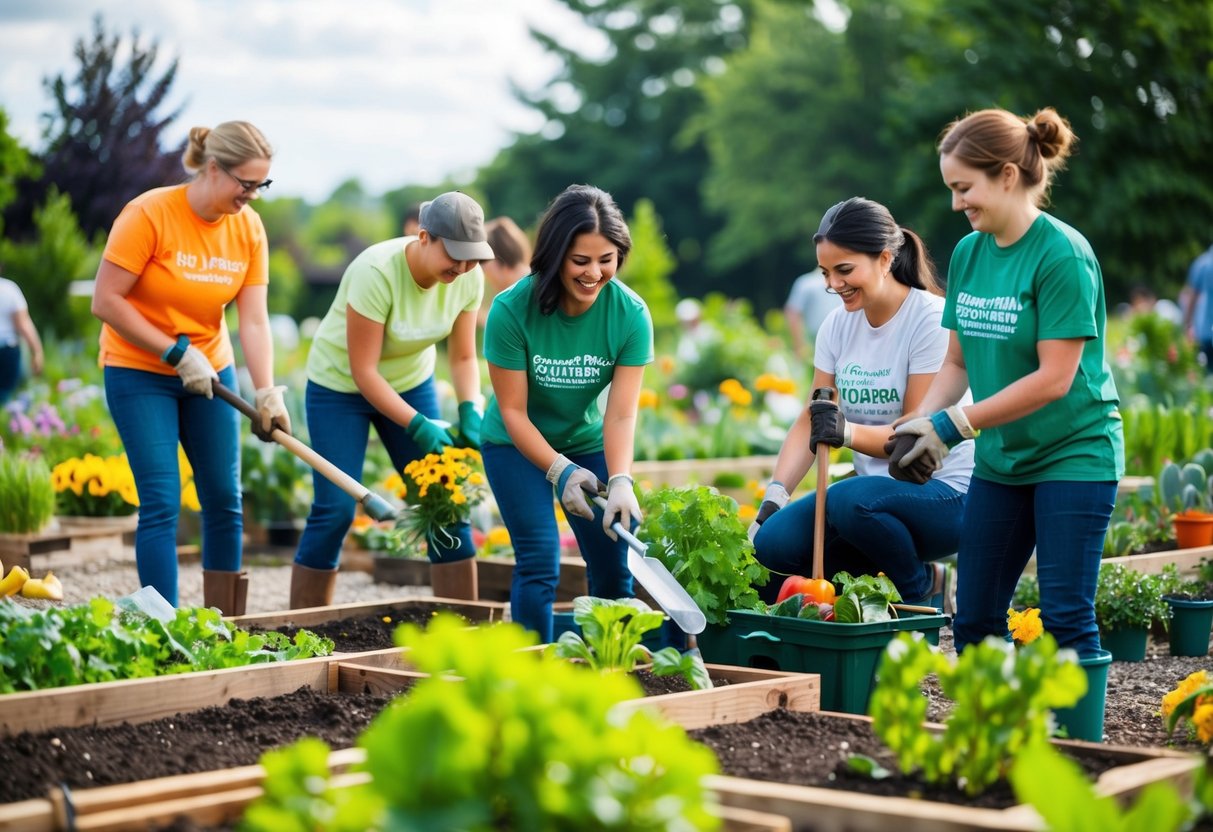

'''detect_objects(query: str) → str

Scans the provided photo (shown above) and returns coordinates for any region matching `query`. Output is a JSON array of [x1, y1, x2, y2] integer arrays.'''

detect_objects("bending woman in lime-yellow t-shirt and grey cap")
[[290, 190, 492, 609]]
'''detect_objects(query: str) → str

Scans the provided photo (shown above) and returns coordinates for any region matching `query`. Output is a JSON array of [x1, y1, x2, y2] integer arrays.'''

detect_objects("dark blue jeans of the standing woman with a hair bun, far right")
[[952, 477, 1116, 657]]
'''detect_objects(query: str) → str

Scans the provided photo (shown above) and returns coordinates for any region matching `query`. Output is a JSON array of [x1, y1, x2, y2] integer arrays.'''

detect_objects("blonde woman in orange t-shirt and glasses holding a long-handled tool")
[[92, 121, 290, 615]]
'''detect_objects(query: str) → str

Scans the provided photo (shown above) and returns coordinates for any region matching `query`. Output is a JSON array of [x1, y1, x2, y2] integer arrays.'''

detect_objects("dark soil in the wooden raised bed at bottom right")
[[688, 711, 1135, 809]]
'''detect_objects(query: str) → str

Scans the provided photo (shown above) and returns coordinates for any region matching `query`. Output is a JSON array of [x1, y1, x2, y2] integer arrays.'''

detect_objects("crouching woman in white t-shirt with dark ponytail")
[[751, 196, 973, 606]]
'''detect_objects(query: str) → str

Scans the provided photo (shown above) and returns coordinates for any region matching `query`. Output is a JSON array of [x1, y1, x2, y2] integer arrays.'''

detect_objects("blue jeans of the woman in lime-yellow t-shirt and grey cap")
[[295, 376, 475, 569]]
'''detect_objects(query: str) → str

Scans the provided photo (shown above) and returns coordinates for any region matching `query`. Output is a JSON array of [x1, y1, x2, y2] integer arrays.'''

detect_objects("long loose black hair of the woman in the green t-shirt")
[[531, 184, 632, 315]]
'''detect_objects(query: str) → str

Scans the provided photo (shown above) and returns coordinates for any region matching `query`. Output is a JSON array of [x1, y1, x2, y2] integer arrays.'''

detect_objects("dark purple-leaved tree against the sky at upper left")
[[29, 15, 184, 237]]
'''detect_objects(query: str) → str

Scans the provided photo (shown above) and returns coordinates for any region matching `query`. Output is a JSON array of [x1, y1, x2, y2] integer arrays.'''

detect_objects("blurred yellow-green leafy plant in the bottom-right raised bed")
[[870, 633, 1087, 794]]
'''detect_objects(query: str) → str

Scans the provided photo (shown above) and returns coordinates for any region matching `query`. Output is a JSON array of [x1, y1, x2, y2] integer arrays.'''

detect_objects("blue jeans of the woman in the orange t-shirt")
[[106, 365, 244, 606]]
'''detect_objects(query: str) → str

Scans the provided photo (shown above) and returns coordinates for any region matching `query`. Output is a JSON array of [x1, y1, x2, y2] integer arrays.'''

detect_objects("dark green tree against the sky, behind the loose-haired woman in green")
[[477, 0, 753, 299]]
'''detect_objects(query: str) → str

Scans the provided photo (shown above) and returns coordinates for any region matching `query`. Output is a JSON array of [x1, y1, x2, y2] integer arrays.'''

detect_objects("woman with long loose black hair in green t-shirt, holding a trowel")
[[482, 186, 653, 643]]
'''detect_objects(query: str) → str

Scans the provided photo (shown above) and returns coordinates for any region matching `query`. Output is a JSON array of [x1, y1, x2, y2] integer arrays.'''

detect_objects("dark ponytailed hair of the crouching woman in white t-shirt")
[[813, 196, 944, 295]]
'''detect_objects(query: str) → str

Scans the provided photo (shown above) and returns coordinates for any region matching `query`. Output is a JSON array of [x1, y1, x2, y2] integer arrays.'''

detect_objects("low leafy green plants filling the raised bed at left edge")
[[0, 597, 332, 693]]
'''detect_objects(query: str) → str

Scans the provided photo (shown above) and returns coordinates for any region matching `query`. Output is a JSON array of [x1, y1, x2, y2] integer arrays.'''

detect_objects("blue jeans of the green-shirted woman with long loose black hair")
[[482, 443, 632, 644]]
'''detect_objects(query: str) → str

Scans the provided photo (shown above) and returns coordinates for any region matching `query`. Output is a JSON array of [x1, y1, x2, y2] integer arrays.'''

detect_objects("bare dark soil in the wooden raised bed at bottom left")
[[0, 688, 407, 803]]
